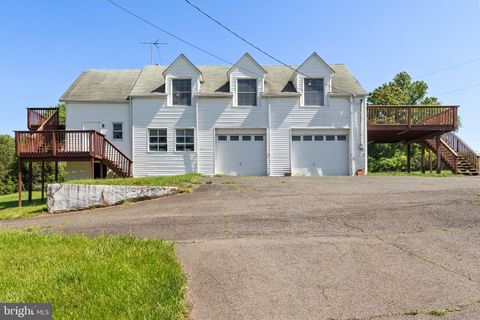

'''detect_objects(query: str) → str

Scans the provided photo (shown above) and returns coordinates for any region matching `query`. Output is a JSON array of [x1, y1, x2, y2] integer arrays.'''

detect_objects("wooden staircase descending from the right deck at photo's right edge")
[[425, 132, 480, 176]]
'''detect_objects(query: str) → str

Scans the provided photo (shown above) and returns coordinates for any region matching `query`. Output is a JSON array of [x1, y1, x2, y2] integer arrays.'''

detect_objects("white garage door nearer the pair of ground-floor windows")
[[215, 132, 267, 176]]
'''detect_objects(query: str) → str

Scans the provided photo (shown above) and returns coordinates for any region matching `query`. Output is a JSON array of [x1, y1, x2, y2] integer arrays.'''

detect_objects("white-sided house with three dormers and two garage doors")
[[60, 53, 367, 178]]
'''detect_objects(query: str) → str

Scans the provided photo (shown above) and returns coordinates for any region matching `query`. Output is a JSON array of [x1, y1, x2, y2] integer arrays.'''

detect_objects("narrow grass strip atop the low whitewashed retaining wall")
[[66, 173, 201, 192]]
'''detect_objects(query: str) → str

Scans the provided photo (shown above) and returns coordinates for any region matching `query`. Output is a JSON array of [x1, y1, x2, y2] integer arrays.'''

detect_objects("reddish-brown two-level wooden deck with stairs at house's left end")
[[15, 108, 132, 177]]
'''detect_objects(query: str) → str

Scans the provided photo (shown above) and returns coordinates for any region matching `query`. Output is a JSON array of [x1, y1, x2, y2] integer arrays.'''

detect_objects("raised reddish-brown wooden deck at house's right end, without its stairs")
[[368, 105, 458, 143]]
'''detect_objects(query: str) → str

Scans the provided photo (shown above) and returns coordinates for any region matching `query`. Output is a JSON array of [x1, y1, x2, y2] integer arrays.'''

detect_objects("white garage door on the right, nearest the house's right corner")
[[292, 130, 349, 176]]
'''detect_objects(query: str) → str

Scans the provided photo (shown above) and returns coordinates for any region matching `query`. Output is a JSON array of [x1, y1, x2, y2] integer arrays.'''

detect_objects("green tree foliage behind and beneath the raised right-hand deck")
[[368, 71, 440, 172]]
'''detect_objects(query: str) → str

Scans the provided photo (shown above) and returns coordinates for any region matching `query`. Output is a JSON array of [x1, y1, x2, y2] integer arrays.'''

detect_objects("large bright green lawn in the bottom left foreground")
[[0, 231, 186, 319]]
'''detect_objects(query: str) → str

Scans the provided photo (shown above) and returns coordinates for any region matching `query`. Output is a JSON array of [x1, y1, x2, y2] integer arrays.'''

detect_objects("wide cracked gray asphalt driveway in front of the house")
[[0, 177, 480, 319]]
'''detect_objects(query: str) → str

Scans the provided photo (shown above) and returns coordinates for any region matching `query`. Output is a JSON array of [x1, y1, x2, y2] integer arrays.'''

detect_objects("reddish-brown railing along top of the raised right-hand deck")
[[368, 105, 458, 128]]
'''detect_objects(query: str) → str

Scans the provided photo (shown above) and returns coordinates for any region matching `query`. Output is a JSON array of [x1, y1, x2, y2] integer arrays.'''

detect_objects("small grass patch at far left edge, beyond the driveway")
[[0, 191, 47, 220]]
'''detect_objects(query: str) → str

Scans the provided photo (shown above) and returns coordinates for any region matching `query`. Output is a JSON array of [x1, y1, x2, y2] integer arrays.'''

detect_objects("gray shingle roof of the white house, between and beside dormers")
[[60, 64, 366, 101]]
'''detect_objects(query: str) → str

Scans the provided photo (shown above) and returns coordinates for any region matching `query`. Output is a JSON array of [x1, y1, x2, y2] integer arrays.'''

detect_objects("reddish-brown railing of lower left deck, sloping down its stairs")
[[15, 130, 132, 175]]
